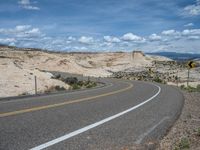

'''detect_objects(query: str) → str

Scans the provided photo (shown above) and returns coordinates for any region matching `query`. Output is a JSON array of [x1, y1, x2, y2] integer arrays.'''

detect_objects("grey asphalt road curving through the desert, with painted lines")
[[0, 79, 184, 150]]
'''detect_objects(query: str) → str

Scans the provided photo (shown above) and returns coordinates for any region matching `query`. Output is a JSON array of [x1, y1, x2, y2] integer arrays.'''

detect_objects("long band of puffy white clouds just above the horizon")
[[0, 25, 200, 51]]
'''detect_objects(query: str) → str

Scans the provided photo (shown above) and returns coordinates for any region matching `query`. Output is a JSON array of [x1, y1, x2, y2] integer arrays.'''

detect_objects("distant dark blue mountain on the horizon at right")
[[146, 52, 200, 61]]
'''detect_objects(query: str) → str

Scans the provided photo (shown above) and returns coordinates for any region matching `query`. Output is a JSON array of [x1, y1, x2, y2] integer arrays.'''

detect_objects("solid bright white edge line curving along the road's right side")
[[31, 85, 161, 150]]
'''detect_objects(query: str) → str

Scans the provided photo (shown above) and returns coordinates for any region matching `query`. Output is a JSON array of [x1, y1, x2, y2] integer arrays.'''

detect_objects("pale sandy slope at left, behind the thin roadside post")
[[0, 59, 69, 97]]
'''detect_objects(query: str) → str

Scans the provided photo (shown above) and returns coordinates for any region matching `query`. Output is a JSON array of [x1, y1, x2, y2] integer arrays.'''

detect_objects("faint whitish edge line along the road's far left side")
[[0, 83, 113, 105]]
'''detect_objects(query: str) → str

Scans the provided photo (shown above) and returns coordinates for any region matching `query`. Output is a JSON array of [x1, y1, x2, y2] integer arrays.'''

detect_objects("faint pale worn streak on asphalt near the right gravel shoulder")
[[135, 116, 170, 144]]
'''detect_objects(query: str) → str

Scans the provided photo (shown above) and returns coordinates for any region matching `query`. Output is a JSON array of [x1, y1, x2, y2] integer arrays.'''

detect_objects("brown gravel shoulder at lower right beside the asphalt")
[[157, 91, 200, 150]]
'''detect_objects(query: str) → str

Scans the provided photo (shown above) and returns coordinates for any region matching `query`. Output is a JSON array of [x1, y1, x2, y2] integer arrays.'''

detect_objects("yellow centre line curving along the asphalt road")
[[0, 82, 133, 118]]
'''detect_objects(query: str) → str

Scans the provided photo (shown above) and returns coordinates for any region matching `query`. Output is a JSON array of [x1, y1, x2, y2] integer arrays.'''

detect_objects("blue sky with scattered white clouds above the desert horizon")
[[0, 0, 200, 53]]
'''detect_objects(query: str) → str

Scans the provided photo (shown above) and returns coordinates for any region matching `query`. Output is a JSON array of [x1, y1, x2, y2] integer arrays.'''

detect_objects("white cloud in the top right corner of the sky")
[[181, 0, 200, 17]]
